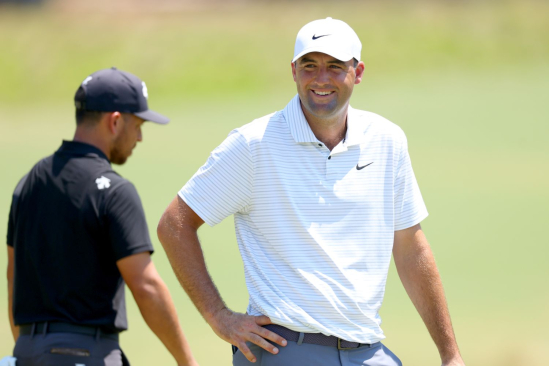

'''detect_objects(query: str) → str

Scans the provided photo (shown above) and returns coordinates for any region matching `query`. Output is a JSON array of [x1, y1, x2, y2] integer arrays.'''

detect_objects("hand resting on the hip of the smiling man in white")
[[211, 308, 288, 362]]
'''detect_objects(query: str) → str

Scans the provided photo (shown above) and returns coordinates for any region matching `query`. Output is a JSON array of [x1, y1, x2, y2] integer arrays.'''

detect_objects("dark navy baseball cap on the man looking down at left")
[[74, 67, 170, 124]]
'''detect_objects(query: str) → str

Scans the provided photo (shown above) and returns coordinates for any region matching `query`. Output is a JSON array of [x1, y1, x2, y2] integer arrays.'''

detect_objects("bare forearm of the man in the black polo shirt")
[[133, 278, 196, 365]]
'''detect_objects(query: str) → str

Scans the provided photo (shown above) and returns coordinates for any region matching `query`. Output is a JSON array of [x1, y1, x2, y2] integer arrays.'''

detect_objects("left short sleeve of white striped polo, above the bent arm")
[[179, 130, 253, 226]]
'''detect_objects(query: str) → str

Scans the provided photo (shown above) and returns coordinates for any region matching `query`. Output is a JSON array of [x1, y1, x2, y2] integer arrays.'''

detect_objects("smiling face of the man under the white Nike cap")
[[292, 52, 364, 122]]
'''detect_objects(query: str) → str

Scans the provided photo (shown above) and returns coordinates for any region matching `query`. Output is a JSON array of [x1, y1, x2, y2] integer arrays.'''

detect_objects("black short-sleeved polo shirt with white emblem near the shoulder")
[[7, 141, 153, 331]]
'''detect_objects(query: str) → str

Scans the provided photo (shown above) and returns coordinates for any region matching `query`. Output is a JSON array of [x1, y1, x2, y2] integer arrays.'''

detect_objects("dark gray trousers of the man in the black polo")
[[13, 333, 125, 366]]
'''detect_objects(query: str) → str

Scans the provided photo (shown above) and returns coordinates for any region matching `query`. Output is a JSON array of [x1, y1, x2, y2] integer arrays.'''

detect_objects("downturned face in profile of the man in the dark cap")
[[110, 113, 145, 165]]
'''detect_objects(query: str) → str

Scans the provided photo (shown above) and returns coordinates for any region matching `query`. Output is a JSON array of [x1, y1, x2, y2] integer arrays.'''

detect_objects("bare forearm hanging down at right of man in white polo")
[[394, 226, 461, 364]]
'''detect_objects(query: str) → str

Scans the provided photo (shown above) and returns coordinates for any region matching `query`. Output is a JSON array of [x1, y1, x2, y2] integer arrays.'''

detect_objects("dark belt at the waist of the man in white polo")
[[263, 324, 379, 350]]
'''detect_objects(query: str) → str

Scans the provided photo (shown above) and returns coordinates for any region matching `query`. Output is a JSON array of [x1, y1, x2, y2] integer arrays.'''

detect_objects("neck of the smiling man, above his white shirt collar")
[[301, 100, 348, 151]]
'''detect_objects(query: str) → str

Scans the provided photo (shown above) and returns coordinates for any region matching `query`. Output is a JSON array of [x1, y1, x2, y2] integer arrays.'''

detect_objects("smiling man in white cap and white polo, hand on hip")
[[158, 18, 464, 366]]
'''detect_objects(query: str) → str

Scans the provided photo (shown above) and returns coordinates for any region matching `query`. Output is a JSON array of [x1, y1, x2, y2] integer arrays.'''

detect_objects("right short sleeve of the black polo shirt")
[[105, 181, 153, 260]]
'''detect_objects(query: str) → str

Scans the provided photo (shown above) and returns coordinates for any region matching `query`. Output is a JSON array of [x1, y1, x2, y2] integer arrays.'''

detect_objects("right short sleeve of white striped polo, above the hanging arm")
[[394, 137, 428, 231]]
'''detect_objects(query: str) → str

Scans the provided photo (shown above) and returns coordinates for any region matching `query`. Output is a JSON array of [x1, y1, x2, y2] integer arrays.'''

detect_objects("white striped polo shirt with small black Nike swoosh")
[[179, 95, 427, 343]]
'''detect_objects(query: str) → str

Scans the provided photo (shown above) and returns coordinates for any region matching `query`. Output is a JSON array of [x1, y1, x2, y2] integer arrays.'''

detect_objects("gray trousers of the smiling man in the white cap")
[[233, 342, 402, 366]]
